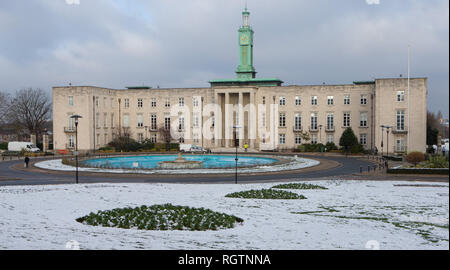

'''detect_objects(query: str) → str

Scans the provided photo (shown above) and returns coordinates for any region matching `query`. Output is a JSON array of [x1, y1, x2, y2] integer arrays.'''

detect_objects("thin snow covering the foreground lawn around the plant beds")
[[0, 180, 449, 250]]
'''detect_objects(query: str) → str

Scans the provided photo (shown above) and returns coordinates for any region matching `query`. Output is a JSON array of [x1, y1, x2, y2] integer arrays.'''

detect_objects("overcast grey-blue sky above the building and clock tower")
[[0, 0, 449, 116]]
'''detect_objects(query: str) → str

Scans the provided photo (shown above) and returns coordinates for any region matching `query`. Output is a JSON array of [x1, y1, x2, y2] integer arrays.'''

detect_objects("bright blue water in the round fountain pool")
[[83, 155, 278, 169]]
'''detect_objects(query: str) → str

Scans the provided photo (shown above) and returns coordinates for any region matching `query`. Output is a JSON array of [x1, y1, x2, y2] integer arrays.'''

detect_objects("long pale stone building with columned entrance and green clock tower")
[[53, 10, 427, 153]]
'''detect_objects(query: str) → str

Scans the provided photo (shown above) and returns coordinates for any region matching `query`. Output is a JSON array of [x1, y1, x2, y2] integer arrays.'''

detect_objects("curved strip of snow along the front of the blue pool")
[[34, 156, 320, 174]]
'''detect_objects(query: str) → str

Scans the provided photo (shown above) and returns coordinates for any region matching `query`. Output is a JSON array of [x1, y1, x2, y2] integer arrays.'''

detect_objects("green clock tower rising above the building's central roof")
[[236, 8, 256, 80]]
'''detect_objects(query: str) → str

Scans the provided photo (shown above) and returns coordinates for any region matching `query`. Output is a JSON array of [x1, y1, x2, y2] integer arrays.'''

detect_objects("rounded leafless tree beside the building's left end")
[[7, 88, 52, 138]]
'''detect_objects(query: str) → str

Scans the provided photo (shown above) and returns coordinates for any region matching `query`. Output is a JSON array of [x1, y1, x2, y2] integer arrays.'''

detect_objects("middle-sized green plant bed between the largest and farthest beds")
[[225, 189, 306, 200]]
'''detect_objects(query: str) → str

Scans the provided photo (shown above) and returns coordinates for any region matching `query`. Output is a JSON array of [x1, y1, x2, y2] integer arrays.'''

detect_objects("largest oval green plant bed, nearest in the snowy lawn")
[[76, 204, 243, 231]]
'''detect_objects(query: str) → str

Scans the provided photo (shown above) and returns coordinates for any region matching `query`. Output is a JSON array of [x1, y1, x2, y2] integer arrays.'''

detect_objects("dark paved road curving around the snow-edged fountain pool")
[[0, 155, 372, 186]]
